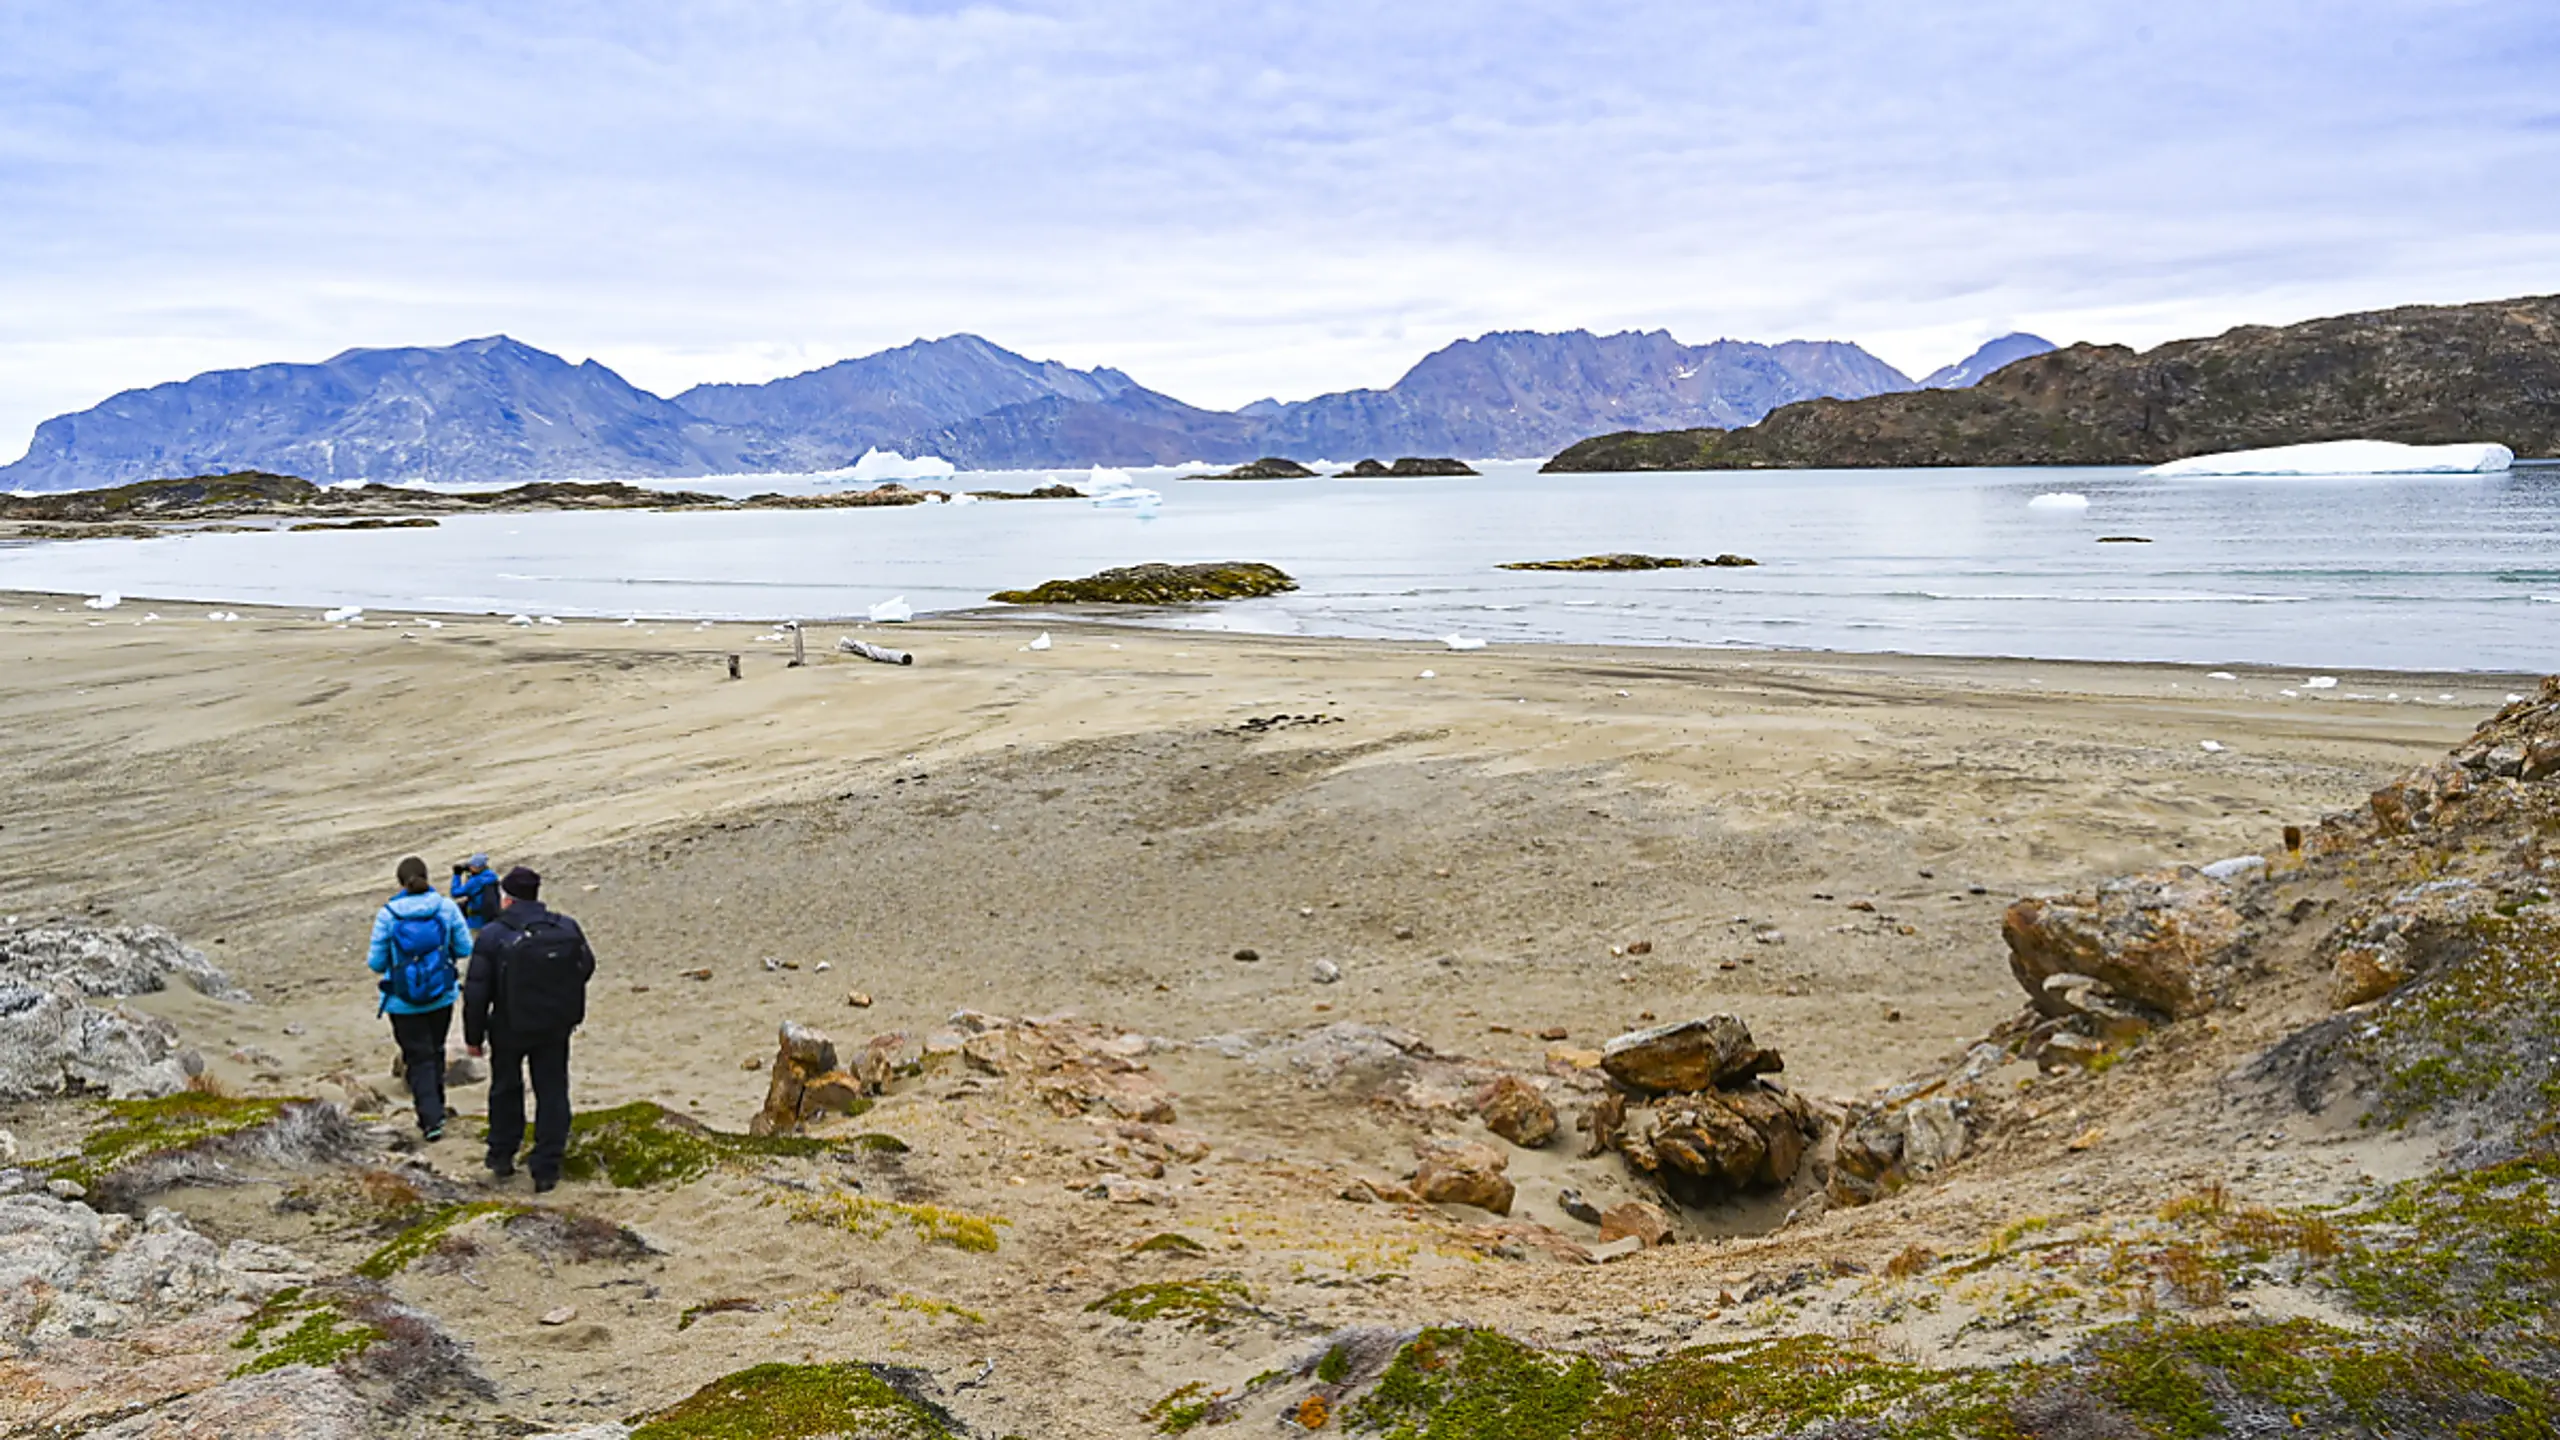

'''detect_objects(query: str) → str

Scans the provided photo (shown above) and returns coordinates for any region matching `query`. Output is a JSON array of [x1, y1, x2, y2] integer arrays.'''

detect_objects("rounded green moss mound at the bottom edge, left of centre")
[[632, 1363, 965, 1440]]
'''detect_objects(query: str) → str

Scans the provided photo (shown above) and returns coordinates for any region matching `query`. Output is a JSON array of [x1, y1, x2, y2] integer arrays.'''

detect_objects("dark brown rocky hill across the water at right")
[[1546, 295, 2560, 471]]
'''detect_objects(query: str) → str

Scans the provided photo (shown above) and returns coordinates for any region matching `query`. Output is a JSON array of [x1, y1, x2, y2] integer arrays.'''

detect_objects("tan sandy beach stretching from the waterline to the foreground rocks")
[[0, 594, 2529, 1435]]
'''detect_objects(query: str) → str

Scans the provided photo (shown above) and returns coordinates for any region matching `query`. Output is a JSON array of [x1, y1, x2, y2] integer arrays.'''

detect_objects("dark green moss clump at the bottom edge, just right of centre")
[[1349, 1327, 1603, 1440]]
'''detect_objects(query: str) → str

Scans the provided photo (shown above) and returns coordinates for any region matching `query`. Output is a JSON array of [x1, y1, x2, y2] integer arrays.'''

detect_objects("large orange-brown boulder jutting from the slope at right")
[[1999, 866, 2248, 1017]]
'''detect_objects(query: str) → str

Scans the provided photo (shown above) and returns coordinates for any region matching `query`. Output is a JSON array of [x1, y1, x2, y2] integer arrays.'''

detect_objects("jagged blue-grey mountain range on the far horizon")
[[0, 331, 2051, 489]]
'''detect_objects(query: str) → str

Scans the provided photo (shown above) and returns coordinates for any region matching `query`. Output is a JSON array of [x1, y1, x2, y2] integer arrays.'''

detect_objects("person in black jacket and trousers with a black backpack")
[[463, 866, 596, 1194]]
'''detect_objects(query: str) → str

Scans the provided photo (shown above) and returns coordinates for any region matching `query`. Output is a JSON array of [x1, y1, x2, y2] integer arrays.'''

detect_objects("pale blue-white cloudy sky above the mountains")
[[0, 0, 2560, 459]]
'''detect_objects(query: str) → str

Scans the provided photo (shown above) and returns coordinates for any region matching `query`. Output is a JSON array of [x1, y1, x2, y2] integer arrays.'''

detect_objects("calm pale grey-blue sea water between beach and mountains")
[[0, 461, 2560, 671]]
